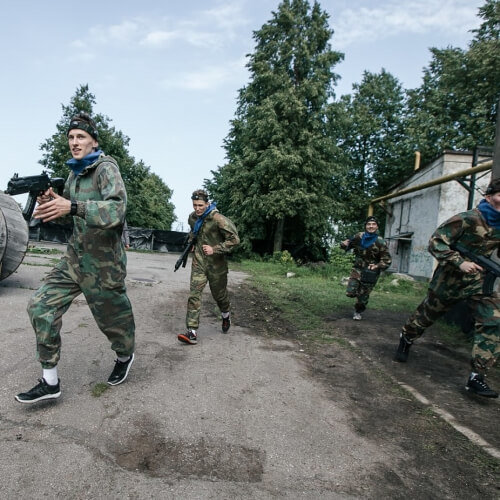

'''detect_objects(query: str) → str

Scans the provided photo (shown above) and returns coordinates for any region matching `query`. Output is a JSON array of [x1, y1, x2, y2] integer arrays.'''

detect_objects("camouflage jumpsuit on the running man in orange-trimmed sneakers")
[[186, 209, 240, 330]]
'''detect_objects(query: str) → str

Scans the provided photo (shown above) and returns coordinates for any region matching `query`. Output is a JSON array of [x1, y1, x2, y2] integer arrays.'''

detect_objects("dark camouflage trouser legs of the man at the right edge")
[[403, 289, 500, 374]]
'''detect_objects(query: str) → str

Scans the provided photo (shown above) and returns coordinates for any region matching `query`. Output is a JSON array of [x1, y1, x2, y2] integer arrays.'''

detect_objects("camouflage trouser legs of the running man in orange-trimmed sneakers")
[[186, 259, 231, 330]]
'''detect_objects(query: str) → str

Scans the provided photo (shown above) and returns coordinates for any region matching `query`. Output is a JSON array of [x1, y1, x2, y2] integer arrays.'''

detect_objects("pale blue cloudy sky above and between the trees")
[[0, 0, 484, 230]]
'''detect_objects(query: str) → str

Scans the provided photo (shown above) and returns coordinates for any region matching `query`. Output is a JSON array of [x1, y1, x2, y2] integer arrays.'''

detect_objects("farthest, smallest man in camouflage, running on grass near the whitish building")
[[340, 216, 392, 320]]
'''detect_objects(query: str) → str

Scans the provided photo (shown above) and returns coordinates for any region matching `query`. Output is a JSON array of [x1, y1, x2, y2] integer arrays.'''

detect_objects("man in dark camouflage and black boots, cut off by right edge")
[[395, 179, 500, 398]]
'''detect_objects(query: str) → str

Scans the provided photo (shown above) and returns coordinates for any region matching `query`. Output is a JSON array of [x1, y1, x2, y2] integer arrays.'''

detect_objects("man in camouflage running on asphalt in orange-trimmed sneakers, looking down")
[[177, 189, 240, 344]]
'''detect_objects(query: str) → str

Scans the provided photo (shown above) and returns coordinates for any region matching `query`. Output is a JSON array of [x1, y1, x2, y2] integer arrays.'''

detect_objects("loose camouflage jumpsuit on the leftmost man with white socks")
[[28, 155, 135, 368]]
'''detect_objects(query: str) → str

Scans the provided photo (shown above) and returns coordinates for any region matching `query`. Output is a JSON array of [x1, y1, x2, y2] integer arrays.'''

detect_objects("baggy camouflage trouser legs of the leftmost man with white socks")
[[27, 258, 135, 368]]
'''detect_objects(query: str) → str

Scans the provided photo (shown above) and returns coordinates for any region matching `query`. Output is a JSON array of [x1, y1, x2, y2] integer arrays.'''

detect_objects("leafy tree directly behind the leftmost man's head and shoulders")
[[39, 85, 175, 230]]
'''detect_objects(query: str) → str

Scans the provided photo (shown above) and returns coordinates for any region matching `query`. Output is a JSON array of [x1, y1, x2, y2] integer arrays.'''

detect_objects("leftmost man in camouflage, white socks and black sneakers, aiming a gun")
[[16, 113, 135, 403]]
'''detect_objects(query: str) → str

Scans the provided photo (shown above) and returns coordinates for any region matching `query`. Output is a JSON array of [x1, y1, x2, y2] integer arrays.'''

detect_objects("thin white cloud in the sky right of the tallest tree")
[[331, 0, 479, 48]]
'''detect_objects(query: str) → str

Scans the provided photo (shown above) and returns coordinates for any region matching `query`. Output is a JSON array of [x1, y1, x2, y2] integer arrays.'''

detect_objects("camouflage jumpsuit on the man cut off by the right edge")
[[403, 209, 500, 374]]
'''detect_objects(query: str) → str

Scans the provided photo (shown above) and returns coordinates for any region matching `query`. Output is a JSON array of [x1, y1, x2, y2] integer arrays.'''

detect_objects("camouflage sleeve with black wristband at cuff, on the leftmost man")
[[81, 161, 127, 229]]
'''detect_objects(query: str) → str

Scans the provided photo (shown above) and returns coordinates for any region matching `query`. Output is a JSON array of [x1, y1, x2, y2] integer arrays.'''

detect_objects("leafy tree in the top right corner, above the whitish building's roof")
[[408, 0, 500, 162]]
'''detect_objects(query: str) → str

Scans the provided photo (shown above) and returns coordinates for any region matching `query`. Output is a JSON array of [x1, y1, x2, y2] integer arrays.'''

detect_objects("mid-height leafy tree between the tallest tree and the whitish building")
[[332, 69, 412, 224]]
